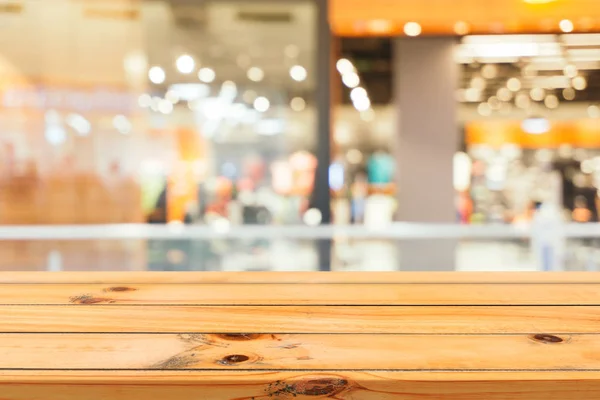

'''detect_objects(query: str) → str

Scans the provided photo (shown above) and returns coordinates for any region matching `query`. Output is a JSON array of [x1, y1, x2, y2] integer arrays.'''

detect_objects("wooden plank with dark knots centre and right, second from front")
[[0, 333, 600, 372]]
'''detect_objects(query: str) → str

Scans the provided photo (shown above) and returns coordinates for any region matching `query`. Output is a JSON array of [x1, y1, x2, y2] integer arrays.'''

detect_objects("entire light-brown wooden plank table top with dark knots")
[[0, 272, 600, 400]]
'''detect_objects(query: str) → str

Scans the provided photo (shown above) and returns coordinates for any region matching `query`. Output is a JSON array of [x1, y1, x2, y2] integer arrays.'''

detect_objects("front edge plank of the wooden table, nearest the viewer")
[[0, 371, 600, 400]]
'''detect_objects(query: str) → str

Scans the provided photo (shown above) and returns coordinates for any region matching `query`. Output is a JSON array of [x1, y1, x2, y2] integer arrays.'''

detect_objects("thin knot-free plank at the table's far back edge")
[[0, 271, 600, 285]]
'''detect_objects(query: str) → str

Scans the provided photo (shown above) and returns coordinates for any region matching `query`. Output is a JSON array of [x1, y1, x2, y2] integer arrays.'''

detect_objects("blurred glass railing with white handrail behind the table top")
[[0, 223, 600, 271]]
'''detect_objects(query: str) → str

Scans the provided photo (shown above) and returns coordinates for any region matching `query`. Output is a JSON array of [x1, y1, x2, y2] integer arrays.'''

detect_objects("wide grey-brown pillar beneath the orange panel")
[[394, 38, 459, 270]]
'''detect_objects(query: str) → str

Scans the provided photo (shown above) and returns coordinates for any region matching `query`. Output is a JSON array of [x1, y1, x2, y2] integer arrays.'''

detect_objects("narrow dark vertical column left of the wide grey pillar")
[[312, 0, 331, 271]]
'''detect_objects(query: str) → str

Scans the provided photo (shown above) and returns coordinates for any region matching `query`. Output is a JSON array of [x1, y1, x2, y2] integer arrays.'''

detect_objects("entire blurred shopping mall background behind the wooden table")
[[0, 0, 600, 271]]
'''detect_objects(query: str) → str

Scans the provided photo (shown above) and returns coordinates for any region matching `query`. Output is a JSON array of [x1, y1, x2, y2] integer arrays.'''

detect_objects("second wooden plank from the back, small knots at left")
[[0, 284, 600, 305]]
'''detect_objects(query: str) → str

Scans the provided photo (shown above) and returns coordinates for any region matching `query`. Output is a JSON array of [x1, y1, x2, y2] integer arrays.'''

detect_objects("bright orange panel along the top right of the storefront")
[[330, 0, 600, 36]]
